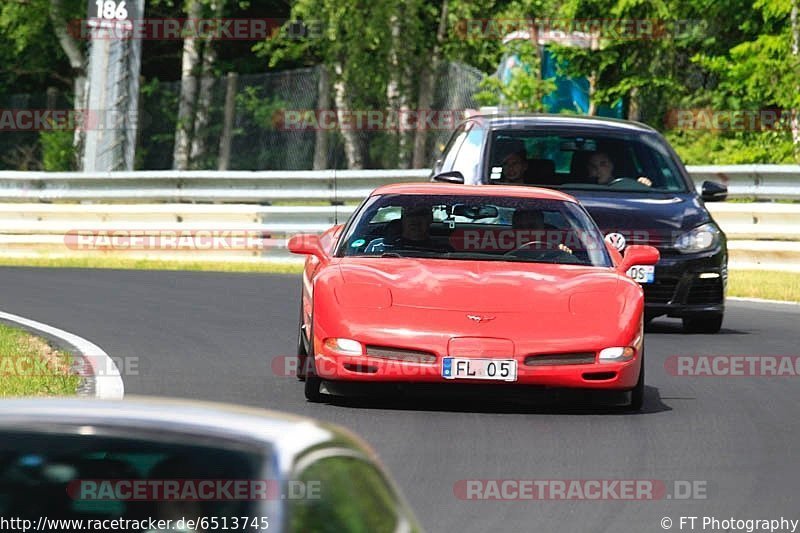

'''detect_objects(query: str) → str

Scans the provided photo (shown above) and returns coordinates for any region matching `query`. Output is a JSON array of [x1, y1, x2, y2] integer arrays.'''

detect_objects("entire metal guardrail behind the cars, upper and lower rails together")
[[0, 165, 800, 270]]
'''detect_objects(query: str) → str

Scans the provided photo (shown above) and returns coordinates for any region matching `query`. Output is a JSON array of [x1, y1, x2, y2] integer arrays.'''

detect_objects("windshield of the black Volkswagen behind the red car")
[[486, 130, 686, 194]]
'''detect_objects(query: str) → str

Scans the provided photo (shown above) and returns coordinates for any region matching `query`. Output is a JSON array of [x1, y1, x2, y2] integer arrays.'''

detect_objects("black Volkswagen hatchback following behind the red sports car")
[[432, 115, 728, 333]]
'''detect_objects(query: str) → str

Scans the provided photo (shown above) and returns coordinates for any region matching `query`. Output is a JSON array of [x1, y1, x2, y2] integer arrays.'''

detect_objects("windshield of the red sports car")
[[336, 194, 611, 267]]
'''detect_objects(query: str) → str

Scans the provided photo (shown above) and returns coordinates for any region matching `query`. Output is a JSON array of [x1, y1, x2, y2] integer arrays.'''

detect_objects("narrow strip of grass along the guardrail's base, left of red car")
[[0, 257, 303, 274]]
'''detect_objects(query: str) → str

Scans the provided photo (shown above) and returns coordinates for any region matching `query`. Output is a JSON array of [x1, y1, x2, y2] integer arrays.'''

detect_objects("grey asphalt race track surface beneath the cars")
[[0, 268, 800, 533]]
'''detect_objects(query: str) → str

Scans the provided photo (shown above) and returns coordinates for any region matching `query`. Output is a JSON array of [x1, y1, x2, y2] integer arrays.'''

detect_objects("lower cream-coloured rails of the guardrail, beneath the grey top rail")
[[0, 203, 800, 270]]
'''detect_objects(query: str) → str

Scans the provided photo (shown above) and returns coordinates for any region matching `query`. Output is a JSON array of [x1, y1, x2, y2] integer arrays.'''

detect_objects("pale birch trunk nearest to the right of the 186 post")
[[172, 0, 202, 170]]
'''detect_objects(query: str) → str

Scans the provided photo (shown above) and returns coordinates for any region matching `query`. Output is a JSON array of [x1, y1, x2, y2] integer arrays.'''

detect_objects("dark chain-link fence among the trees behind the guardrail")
[[0, 63, 483, 170]]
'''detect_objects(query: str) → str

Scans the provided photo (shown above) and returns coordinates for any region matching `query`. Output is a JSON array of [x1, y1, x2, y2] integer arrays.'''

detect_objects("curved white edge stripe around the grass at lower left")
[[0, 311, 125, 400]]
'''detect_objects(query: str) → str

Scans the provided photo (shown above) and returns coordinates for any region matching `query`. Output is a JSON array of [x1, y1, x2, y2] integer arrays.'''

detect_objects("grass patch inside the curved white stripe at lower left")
[[0, 324, 80, 397]]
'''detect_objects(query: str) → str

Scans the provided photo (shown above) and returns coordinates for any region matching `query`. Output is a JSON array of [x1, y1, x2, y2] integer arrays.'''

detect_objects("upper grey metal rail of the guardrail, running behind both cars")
[[0, 165, 800, 203]]
